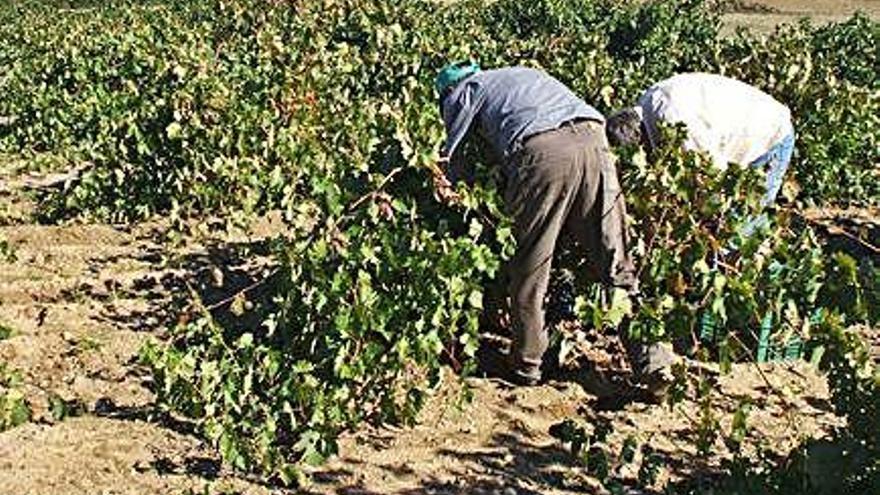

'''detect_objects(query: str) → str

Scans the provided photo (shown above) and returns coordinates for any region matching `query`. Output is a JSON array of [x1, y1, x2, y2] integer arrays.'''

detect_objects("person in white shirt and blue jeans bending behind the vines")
[[607, 73, 794, 206]]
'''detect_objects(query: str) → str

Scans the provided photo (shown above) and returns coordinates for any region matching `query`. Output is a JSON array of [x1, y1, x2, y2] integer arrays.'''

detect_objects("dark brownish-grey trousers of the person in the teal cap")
[[504, 121, 636, 370]]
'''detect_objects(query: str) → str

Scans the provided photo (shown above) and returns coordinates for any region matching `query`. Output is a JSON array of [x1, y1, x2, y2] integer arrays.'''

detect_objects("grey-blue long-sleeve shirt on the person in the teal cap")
[[442, 67, 605, 179]]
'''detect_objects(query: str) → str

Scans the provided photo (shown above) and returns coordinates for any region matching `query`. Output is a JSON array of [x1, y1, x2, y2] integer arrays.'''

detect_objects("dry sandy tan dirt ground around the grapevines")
[[0, 0, 880, 495]]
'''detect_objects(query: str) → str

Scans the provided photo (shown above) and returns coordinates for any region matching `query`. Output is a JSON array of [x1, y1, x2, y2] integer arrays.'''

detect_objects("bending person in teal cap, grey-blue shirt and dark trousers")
[[435, 62, 652, 384]]
